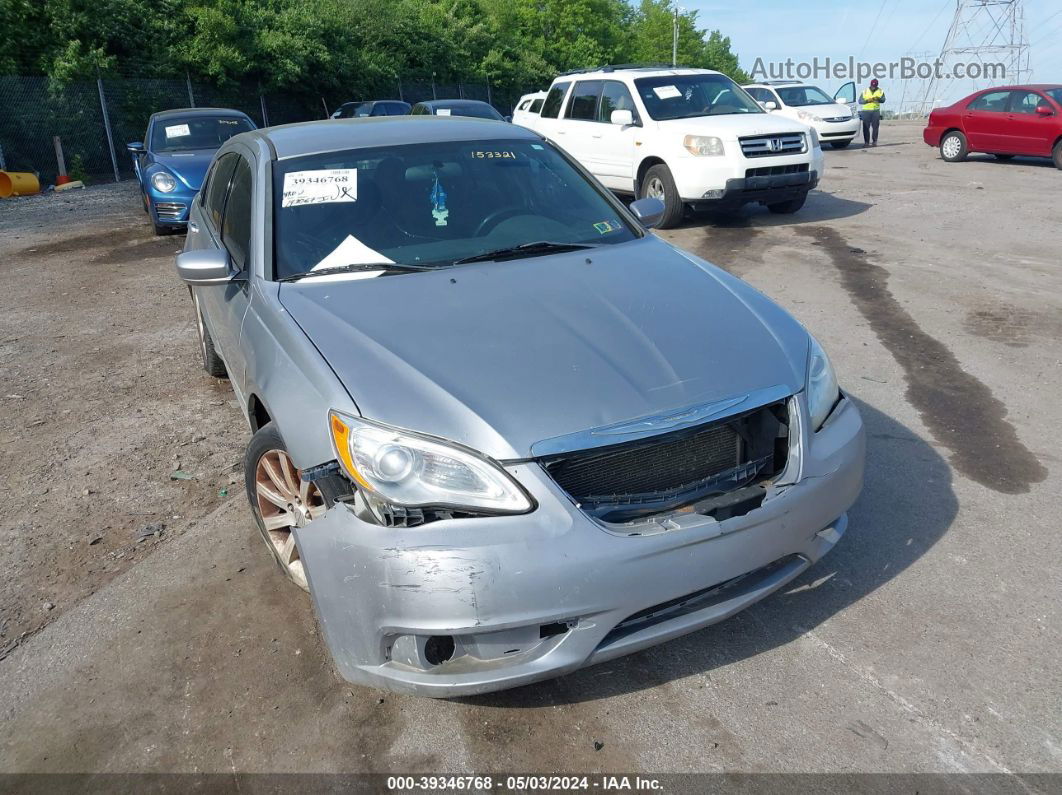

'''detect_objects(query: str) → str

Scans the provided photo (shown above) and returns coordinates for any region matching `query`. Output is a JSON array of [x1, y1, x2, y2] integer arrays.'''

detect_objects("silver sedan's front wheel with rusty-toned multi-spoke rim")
[[243, 422, 335, 590]]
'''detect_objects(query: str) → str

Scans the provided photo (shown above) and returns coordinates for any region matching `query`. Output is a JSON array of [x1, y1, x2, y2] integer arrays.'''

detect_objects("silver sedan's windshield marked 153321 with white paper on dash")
[[273, 139, 638, 278]]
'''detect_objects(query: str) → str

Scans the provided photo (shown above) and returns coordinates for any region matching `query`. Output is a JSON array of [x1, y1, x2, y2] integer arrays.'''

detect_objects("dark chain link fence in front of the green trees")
[[0, 75, 531, 186]]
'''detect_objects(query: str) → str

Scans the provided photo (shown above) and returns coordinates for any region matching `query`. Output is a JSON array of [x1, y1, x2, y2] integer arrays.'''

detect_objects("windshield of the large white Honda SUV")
[[634, 74, 764, 121]]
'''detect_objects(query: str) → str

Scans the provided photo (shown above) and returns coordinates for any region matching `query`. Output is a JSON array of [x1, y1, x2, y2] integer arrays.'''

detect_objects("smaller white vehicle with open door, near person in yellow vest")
[[742, 81, 859, 149]]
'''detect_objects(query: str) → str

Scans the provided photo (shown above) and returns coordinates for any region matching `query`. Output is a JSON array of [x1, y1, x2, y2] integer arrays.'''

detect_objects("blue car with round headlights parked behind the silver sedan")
[[126, 107, 255, 235]]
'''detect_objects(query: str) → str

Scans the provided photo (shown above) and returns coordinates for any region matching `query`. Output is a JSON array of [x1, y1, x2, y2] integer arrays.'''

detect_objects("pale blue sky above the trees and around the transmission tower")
[[679, 0, 1062, 109]]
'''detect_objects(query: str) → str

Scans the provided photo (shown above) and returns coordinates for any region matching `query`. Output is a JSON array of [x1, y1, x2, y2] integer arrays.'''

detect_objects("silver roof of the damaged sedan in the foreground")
[[243, 116, 542, 160]]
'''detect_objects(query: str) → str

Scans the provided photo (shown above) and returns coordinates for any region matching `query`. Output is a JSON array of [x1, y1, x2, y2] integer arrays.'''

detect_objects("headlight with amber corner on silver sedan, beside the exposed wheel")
[[328, 412, 532, 514]]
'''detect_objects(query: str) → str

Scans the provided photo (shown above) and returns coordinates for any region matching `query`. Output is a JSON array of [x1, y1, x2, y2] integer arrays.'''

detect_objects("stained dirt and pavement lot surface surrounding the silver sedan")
[[0, 124, 1062, 776]]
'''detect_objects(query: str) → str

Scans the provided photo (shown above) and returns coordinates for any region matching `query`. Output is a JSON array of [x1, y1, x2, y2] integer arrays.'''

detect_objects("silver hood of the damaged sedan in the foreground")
[[279, 236, 808, 459]]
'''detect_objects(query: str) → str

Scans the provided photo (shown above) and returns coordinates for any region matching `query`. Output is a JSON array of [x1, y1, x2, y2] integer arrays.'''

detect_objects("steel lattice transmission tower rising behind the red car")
[[922, 0, 1030, 114]]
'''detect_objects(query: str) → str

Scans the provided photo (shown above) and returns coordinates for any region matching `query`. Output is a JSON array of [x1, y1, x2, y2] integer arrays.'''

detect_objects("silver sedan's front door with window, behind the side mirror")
[[193, 152, 254, 388]]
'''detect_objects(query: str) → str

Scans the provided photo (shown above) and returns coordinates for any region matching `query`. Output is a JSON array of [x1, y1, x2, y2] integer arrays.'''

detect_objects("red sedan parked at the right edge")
[[922, 85, 1062, 169]]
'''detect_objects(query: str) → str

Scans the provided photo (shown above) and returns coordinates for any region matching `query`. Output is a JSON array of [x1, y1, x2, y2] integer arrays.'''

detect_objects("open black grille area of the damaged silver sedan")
[[539, 401, 788, 521]]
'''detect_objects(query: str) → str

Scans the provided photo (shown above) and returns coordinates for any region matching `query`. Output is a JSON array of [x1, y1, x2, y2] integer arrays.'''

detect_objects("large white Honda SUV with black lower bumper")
[[523, 66, 822, 228]]
